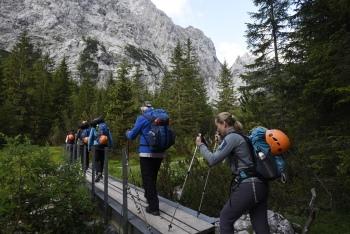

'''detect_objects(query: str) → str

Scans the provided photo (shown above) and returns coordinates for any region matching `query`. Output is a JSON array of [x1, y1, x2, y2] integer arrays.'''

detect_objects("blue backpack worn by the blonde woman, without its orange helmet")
[[235, 127, 286, 182]]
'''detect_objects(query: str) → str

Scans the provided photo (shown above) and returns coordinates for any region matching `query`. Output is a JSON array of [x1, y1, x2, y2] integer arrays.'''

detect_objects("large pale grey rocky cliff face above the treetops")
[[0, 0, 252, 99]]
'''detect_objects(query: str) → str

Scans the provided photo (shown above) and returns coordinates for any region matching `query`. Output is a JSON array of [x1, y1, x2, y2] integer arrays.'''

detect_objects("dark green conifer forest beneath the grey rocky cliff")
[[0, 0, 350, 232]]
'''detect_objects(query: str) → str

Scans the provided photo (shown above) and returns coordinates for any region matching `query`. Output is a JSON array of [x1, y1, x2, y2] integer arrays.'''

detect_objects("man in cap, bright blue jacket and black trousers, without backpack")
[[126, 101, 165, 216]]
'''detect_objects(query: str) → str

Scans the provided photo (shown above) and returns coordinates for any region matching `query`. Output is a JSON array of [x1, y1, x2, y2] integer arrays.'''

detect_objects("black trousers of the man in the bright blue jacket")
[[140, 157, 163, 211]]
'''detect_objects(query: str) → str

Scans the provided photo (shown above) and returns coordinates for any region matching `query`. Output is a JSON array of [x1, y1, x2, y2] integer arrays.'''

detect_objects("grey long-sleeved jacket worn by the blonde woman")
[[199, 129, 260, 182]]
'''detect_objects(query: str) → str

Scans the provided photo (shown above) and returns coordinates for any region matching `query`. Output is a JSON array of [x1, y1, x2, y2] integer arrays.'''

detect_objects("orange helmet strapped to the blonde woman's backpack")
[[265, 129, 290, 155]]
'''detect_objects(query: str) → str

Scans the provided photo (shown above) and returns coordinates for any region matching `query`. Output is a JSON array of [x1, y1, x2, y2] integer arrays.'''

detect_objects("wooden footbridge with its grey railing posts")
[[85, 148, 217, 234]]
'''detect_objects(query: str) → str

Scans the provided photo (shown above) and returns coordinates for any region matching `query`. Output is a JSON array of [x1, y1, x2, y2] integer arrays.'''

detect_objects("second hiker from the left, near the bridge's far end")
[[75, 120, 90, 171]]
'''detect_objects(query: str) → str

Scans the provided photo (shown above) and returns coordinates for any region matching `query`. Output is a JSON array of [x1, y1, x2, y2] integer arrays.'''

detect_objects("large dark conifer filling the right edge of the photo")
[[287, 0, 350, 208]]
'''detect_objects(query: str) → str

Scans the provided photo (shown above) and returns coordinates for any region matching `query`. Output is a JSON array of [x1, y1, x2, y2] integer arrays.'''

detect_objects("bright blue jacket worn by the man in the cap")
[[126, 109, 165, 153]]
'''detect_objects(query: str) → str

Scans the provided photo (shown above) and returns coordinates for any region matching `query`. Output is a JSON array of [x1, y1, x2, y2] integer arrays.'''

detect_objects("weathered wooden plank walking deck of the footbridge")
[[86, 171, 214, 234]]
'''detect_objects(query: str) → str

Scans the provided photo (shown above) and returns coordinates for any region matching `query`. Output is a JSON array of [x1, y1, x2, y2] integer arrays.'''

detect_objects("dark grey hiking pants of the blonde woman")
[[220, 182, 270, 234]]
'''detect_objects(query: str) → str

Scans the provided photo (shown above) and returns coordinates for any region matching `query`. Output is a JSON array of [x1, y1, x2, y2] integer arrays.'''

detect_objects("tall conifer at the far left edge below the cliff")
[[1, 31, 40, 136]]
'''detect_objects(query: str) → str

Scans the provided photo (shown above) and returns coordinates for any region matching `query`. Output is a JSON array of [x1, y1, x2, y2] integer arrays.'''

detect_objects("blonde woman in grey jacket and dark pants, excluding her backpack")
[[196, 112, 270, 234]]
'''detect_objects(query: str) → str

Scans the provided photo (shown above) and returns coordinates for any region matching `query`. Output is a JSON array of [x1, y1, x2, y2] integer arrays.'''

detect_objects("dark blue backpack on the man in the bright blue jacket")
[[143, 109, 175, 152]]
